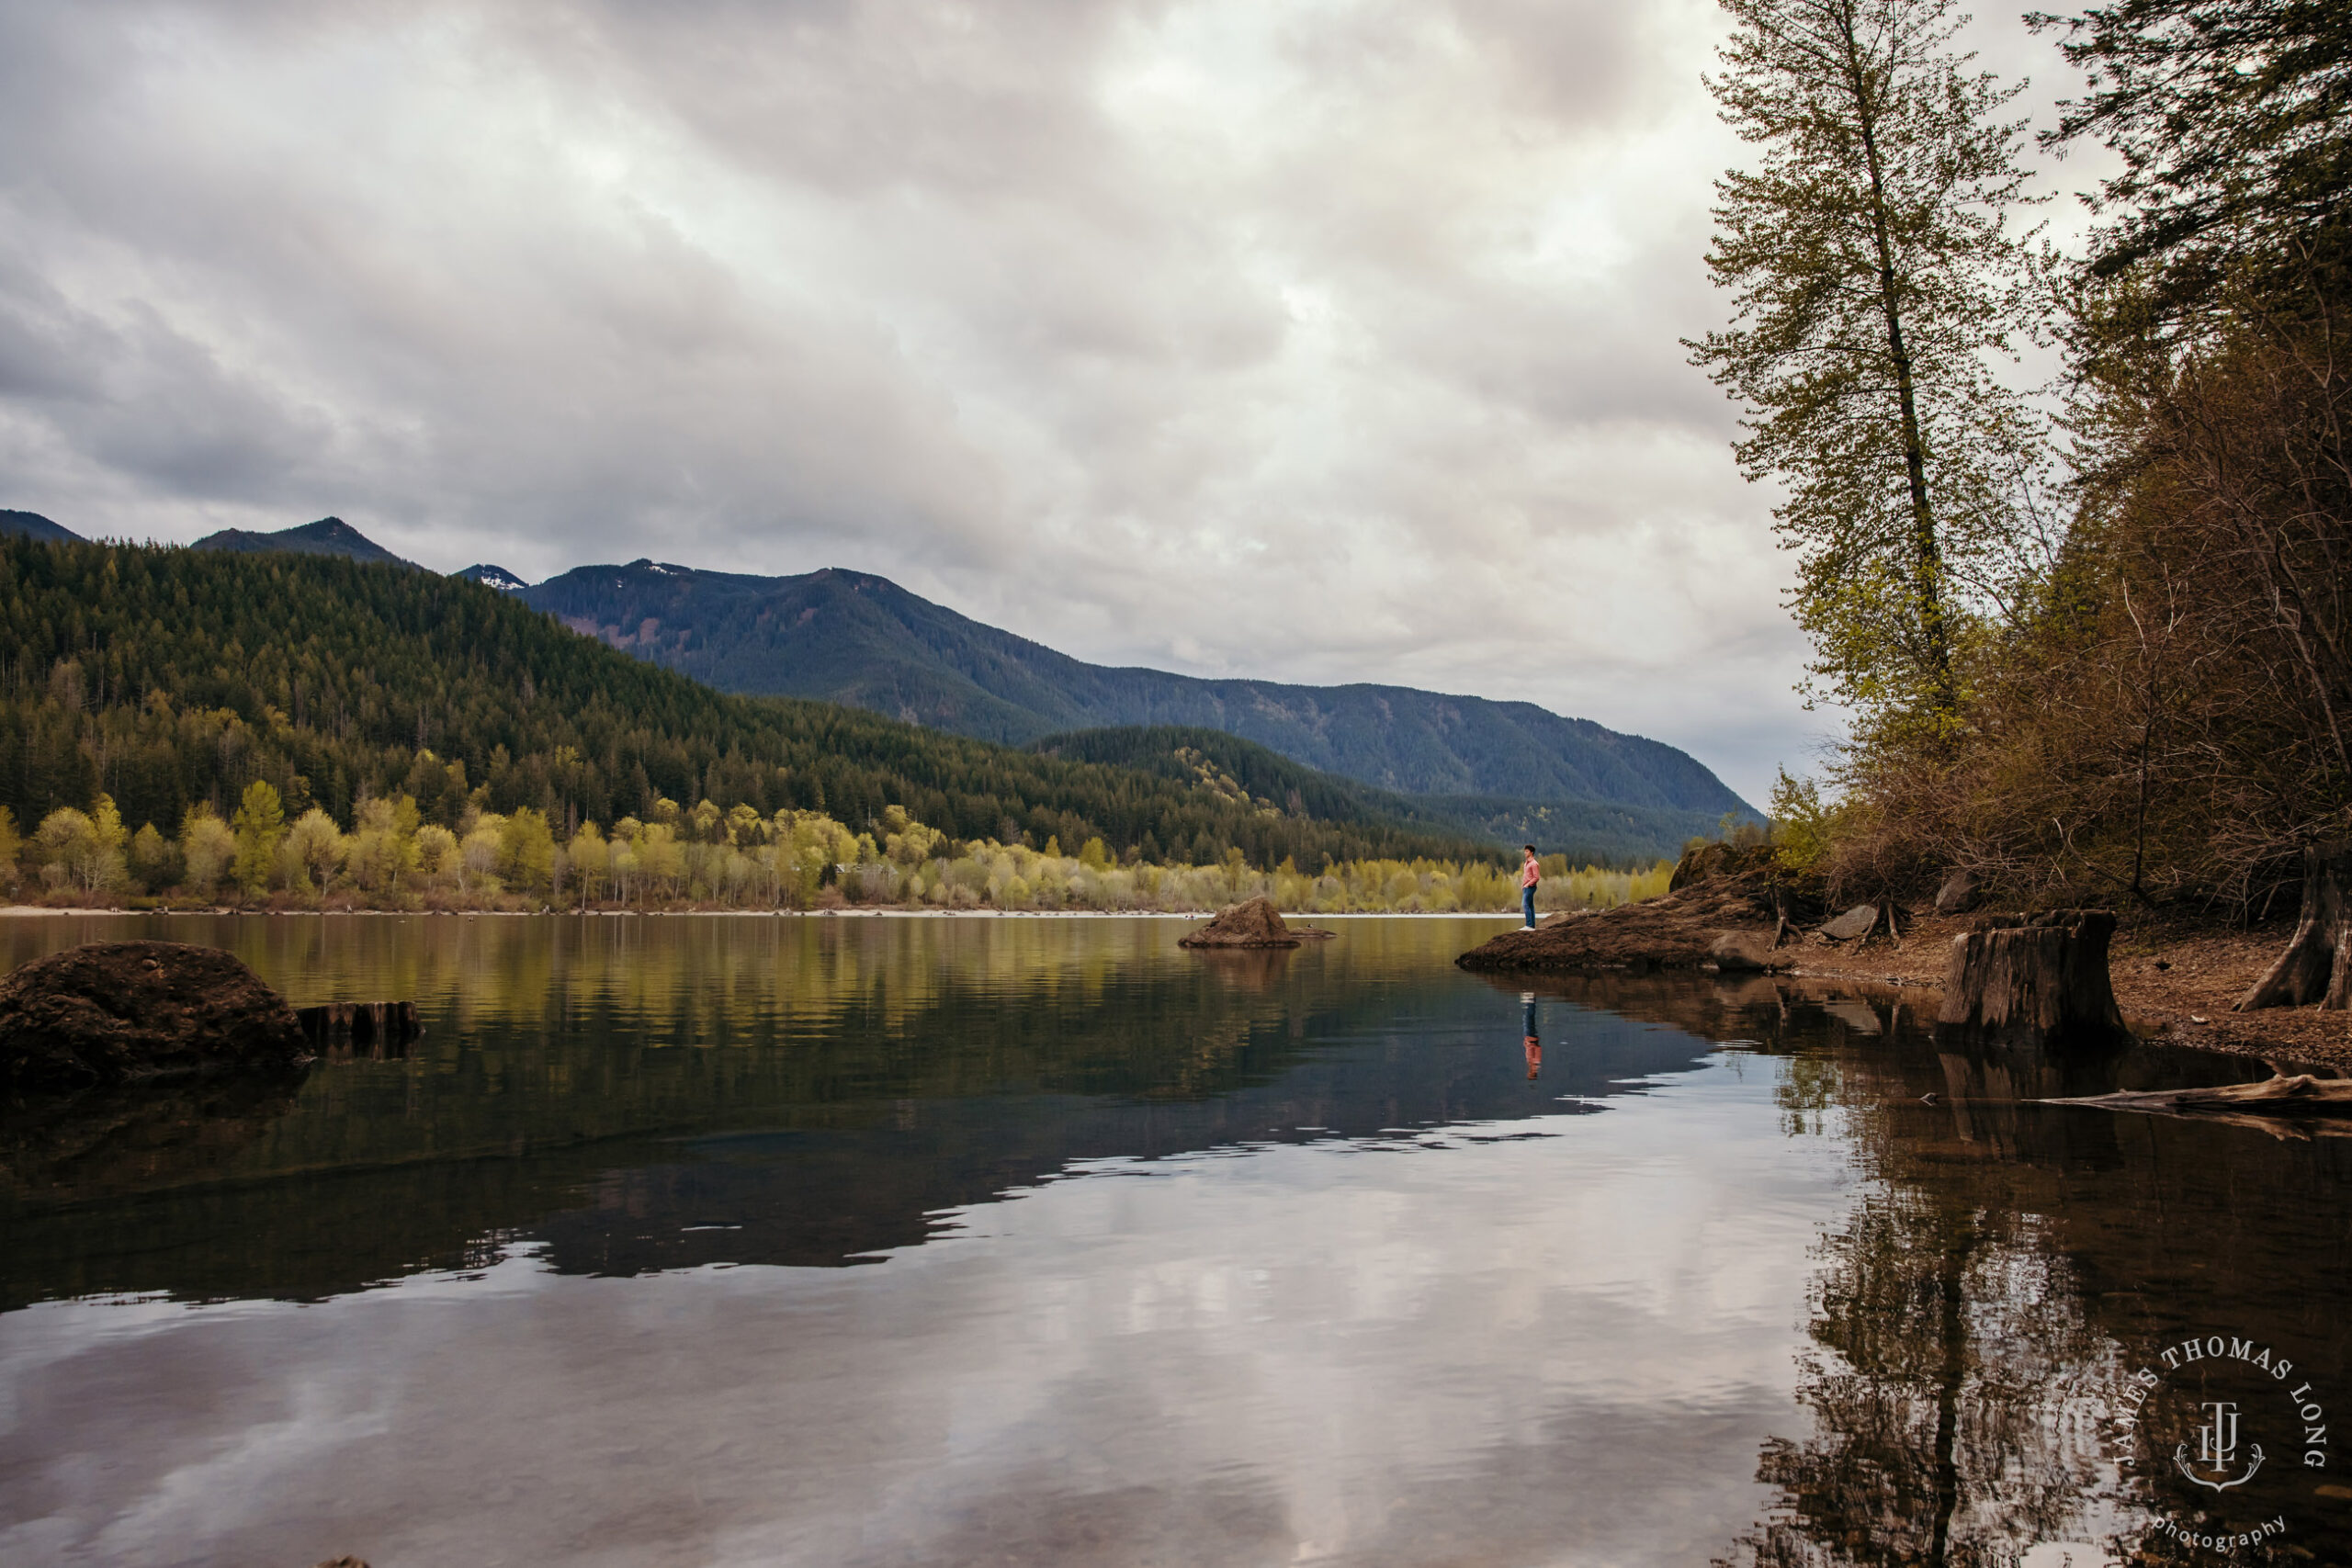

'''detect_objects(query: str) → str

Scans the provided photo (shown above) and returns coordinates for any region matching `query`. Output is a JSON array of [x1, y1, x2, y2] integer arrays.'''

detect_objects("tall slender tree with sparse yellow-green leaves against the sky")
[[1689, 0, 2044, 728]]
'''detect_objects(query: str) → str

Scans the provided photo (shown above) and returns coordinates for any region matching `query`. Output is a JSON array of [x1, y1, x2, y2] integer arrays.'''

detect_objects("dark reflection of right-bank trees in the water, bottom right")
[[1719, 997, 2347, 1568]]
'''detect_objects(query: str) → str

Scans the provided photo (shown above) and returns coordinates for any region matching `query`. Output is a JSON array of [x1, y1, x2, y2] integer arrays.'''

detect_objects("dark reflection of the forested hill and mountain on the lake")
[[14, 919, 1696, 1304]]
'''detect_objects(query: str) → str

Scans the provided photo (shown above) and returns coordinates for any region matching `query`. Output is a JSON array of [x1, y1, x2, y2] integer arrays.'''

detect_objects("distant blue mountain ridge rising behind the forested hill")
[[520, 559, 1755, 808]]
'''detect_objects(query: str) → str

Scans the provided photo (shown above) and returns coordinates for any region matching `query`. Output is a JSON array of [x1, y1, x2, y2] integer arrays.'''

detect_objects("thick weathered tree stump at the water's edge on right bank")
[[1936, 909, 2126, 1043]]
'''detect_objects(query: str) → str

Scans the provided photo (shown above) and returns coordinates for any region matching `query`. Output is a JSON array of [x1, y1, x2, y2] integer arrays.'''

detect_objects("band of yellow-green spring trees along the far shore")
[[9, 783, 1670, 912]]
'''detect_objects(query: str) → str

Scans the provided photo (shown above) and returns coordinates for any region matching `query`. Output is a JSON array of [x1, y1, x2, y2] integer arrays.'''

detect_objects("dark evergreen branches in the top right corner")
[[2030, 0, 2352, 339]]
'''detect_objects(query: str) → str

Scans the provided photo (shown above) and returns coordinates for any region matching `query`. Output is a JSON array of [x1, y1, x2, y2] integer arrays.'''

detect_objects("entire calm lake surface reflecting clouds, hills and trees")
[[0, 917, 2352, 1568]]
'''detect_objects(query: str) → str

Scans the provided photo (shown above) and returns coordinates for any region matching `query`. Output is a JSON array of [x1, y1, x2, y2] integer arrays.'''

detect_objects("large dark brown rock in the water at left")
[[0, 942, 311, 1089]]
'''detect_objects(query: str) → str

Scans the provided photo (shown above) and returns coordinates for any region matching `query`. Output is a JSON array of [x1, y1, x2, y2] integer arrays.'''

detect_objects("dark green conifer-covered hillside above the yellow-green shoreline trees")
[[0, 538, 1494, 865]]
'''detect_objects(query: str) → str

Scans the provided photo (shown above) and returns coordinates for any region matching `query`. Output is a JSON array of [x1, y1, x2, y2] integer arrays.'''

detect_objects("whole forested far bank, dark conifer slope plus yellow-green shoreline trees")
[[0, 538, 1663, 909]]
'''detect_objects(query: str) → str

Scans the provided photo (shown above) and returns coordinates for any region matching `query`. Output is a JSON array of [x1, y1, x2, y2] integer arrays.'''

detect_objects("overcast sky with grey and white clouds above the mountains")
[[0, 0, 2072, 799]]
